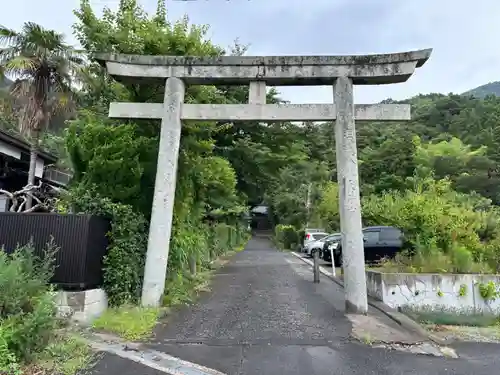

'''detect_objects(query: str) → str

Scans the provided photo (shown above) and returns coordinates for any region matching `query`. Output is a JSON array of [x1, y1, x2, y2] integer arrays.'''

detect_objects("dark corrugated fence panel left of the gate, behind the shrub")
[[0, 212, 110, 290]]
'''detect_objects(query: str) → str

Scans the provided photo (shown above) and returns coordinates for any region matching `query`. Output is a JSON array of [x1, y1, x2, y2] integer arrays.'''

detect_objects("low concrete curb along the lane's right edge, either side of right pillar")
[[290, 251, 448, 345]]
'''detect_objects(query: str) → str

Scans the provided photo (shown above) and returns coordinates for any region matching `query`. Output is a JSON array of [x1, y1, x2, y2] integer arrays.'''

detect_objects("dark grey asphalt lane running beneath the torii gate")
[[93, 238, 500, 375]]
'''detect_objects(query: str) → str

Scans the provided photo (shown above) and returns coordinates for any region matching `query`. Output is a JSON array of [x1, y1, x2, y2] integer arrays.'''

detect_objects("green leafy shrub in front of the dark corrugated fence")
[[0, 243, 56, 373]]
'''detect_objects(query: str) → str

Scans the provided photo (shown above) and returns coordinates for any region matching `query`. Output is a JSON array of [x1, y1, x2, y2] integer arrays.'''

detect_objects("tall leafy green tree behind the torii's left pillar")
[[70, 0, 248, 282]]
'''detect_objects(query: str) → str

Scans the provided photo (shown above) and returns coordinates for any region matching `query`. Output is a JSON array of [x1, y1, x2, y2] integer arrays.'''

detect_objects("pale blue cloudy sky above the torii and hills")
[[0, 0, 500, 104]]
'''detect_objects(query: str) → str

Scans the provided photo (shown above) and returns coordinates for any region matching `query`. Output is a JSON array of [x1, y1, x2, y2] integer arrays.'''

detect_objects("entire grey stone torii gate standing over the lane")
[[95, 49, 432, 313]]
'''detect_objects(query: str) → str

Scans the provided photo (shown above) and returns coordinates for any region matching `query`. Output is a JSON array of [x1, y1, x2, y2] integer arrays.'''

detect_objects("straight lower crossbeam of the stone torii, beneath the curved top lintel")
[[109, 103, 411, 122]]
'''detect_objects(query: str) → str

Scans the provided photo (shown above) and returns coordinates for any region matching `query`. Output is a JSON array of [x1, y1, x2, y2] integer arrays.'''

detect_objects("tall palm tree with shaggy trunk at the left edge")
[[0, 22, 83, 209]]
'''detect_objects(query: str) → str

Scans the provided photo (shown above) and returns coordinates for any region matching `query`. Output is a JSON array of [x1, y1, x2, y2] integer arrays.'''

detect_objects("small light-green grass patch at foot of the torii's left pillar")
[[92, 305, 160, 341]]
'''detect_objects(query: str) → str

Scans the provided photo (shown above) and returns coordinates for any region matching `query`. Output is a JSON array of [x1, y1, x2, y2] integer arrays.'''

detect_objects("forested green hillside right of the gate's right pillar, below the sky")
[[359, 94, 500, 204]]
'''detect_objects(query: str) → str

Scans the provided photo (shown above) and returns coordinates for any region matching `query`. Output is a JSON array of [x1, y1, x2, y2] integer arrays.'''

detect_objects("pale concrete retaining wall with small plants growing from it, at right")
[[366, 270, 500, 314]]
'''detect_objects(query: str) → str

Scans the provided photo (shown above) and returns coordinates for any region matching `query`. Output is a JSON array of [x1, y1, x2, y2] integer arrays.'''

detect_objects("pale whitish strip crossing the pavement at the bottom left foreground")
[[87, 335, 225, 375]]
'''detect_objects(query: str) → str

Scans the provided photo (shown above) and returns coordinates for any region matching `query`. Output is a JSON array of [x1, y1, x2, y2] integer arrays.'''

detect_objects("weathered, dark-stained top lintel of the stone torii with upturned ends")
[[94, 49, 432, 86]]
